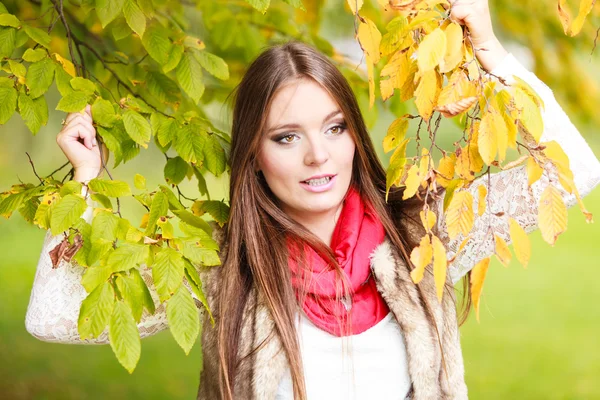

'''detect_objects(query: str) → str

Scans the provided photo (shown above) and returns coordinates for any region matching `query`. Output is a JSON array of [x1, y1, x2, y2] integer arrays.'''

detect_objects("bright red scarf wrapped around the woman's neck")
[[288, 186, 389, 337]]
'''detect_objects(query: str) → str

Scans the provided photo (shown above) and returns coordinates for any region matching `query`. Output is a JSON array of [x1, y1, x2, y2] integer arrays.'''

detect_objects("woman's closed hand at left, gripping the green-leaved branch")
[[56, 104, 108, 181]]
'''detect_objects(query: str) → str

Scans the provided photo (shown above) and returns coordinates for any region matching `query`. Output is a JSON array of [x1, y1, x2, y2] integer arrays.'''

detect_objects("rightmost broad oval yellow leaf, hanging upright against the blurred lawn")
[[538, 185, 567, 246]]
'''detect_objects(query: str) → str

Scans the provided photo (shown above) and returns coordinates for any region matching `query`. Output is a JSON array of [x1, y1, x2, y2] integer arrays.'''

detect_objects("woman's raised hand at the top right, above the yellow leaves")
[[449, 0, 508, 72]]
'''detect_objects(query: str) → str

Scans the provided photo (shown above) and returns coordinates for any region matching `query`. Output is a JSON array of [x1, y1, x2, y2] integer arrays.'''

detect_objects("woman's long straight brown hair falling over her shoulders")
[[217, 41, 474, 400]]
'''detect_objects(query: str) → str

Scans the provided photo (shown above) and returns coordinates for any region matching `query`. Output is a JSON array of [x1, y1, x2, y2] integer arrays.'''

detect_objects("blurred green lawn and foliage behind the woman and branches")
[[0, 1, 600, 399]]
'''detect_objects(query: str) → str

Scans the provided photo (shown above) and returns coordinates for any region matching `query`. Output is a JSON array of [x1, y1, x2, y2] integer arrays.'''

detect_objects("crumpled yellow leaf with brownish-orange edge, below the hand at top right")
[[435, 71, 477, 117]]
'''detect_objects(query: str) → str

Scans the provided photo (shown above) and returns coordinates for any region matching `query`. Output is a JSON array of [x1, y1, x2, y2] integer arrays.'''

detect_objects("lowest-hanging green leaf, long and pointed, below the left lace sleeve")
[[108, 301, 142, 373]]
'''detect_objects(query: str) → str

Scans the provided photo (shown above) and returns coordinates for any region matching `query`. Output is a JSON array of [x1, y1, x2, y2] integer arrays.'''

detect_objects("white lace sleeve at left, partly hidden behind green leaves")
[[25, 184, 213, 344]]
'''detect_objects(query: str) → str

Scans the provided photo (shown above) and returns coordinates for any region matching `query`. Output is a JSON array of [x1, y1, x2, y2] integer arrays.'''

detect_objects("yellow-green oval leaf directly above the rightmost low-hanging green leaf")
[[152, 247, 184, 302]]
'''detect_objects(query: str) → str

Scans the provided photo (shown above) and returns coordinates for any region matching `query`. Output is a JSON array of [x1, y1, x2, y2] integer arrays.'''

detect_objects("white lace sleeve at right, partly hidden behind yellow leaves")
[[437, 54, 600, 284]]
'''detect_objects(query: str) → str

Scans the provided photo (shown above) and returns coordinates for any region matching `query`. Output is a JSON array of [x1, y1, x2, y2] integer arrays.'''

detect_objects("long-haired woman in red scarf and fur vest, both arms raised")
[[27, 0, 600, 399]]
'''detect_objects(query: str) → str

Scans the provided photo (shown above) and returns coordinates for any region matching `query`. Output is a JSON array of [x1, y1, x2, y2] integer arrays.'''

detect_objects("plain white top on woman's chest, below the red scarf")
[[275, 312, 411, 400]]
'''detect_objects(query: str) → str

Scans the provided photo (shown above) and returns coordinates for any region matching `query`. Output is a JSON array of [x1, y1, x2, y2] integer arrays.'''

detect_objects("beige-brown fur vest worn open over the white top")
[[198, 225, 467, 400]]
